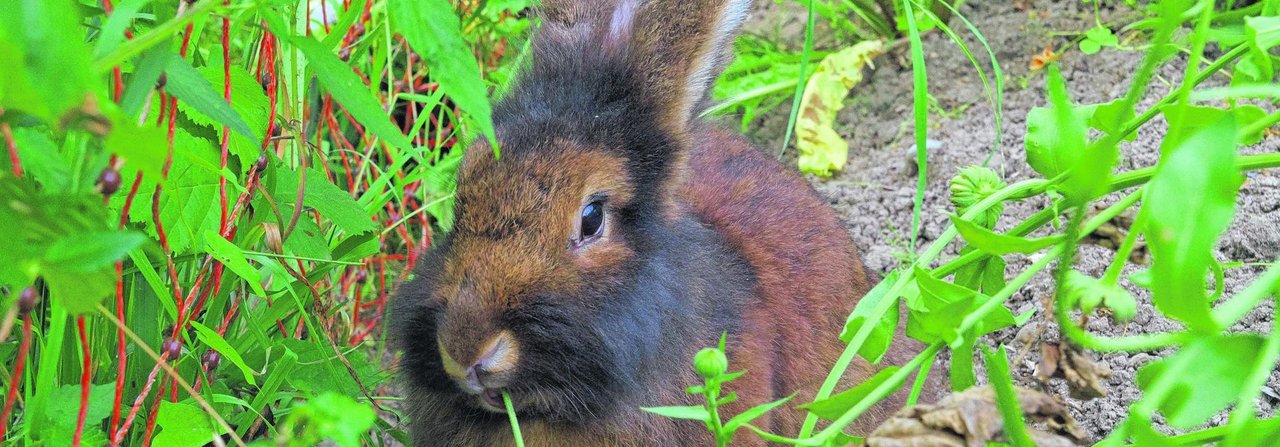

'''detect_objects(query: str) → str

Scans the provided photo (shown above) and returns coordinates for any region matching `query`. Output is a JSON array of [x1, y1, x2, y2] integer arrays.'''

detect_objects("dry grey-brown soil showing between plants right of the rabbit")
[[742, 0, 1280, 439]]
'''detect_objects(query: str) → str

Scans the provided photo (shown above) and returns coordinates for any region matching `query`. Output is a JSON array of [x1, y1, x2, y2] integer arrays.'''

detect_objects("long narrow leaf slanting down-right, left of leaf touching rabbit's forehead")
[[288, 35, 412, 150]]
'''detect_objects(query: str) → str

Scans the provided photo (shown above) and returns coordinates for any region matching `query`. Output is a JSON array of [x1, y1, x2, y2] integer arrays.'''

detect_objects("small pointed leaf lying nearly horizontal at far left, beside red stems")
[[45, 231, 147, 273]]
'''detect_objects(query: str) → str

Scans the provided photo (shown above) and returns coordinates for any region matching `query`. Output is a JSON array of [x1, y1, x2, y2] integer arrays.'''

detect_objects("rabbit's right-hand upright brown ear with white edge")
[[627, 0, 751, 134]]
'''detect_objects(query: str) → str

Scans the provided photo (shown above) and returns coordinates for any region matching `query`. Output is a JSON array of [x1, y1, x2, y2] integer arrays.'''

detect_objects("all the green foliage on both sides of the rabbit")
[[0, 0, 1280, 446]]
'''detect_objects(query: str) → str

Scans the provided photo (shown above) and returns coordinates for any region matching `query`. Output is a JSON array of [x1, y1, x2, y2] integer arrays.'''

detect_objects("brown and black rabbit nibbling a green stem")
[[392, 0, 918, 446]]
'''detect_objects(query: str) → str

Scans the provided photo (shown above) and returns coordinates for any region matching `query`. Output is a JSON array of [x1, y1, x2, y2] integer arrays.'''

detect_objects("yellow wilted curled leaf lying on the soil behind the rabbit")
[[796, 41, 884, 177]]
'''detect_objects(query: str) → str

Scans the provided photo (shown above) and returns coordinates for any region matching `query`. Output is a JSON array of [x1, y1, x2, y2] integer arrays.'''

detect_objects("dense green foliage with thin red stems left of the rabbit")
[[0, 0, 530, 446]]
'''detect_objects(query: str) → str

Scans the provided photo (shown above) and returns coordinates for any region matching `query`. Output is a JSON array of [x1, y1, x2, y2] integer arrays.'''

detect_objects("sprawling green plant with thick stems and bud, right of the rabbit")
[[650, 0, 1280, 446]]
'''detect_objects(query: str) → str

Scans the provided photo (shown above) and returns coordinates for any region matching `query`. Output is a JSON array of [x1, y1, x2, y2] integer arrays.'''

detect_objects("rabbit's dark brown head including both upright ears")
[[393, 0, 750, 420]]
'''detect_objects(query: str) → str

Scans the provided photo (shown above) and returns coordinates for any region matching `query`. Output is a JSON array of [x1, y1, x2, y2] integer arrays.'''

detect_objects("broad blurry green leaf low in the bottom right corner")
[[1138, 334, 1263, 429]]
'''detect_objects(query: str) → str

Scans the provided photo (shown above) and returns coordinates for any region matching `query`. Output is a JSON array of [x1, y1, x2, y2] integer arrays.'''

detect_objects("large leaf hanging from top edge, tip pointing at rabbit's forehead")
[[384, 0, 498, 150]]
